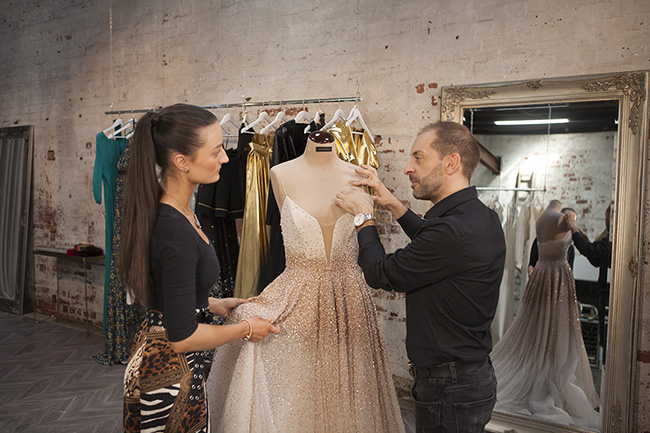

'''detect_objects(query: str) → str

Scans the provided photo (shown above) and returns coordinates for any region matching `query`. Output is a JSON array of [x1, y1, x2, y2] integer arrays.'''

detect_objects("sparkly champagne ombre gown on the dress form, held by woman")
[[207, 197, 404, 433]]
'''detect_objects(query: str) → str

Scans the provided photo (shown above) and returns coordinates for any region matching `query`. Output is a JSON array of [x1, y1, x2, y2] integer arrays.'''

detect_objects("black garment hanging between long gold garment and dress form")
[[257, 119, 322, 292]]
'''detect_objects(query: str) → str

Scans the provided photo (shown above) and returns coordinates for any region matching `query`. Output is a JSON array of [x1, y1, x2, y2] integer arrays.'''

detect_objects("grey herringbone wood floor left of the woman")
[[0, 312, 125, 433]]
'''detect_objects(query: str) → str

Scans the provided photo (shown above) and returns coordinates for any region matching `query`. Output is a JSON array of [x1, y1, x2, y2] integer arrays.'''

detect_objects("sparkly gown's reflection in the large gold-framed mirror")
[[491, 232, 600, 429]]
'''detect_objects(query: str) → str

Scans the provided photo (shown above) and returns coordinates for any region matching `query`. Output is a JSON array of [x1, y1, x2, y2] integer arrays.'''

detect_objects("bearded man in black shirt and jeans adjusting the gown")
[[337, 122, 506, 433]]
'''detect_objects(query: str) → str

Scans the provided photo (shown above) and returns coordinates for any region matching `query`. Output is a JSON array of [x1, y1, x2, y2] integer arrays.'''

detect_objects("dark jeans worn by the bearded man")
[[411, 360, 497, 433]]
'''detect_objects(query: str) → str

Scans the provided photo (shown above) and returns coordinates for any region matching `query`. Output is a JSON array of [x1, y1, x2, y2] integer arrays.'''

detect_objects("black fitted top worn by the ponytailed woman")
[[149, 203, 219, 341]]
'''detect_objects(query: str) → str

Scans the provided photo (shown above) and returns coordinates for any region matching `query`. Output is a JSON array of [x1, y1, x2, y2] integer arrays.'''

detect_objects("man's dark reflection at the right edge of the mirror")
[[568, 206, 612, 363]]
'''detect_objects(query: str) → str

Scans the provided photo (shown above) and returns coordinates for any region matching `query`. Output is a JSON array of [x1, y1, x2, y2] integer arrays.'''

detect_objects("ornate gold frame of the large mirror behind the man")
[[441, 71, 648, 433]]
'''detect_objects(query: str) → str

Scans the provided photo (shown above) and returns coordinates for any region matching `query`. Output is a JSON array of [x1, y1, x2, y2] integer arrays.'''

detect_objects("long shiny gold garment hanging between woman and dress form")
[[234, 134, 274, 298]]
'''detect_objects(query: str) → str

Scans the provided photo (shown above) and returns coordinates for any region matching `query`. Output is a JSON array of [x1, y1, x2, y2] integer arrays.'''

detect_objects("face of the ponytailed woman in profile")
[[188, 122, 228, 183]]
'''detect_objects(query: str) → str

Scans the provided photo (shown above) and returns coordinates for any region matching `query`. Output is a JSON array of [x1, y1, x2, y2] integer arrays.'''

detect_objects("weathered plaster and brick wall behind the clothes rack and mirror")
[[0, 0, 650, 432]]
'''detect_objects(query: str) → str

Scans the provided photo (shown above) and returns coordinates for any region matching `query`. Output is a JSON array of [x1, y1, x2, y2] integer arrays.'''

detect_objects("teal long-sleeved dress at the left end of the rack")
[[93, 132, 129, 334]]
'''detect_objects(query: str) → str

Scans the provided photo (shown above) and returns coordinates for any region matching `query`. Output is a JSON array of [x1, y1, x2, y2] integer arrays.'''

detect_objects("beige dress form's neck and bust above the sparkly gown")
[[271, 131, 359, 255]]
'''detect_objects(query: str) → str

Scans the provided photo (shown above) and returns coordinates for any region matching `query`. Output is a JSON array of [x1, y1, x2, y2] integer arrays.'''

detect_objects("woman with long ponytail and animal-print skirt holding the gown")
[[119, 104, 279, 433]]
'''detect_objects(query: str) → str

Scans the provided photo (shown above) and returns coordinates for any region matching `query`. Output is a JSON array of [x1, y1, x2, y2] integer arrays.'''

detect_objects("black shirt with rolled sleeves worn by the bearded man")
[[359, 187, 506, 367]]
